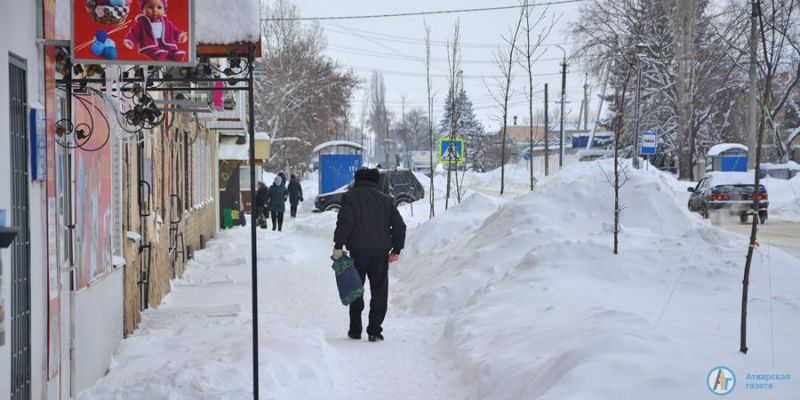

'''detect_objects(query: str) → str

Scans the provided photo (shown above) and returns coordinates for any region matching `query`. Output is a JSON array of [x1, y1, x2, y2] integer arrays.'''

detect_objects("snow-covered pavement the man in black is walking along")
[[79, 214, 469, 400]]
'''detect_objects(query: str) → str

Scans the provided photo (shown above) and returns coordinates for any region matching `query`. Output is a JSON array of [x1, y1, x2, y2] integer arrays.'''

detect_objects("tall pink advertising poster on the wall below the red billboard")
[[74, 95, 113, 290]]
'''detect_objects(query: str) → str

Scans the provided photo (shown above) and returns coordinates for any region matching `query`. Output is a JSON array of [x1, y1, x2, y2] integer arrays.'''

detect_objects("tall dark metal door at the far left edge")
[[8, 55, 31, 400]]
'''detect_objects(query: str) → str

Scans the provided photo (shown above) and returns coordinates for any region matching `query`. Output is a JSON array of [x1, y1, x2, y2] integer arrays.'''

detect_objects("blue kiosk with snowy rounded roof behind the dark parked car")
[[314, 140, 366, 194]]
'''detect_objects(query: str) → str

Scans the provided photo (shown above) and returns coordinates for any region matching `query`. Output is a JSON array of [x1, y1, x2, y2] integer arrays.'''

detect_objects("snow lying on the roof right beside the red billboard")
[[195, 0, 261, 44]]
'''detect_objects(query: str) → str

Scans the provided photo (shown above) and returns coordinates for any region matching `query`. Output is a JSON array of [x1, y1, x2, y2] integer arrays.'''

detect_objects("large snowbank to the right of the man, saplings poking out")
[[393, 162, 800, 399]]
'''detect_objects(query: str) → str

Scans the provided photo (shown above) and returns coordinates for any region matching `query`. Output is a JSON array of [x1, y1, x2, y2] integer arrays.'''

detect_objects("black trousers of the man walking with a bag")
[[349, 254, 389, 335]]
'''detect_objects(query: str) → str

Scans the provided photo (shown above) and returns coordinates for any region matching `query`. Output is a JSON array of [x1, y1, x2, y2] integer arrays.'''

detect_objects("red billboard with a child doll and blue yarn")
[[72, 0, 195, 65]]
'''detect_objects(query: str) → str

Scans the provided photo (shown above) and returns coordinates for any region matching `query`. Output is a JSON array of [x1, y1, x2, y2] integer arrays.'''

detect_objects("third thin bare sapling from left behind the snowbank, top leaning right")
[[490, 7, 528, 196]]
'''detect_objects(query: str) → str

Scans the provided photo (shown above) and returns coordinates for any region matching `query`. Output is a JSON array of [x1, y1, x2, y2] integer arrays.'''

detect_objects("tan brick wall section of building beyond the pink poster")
[[123, 111, 216, 336]]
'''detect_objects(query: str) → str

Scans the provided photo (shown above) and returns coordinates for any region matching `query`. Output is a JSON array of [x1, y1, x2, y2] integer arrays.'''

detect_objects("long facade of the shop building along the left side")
[[0, 0, 256, 400]]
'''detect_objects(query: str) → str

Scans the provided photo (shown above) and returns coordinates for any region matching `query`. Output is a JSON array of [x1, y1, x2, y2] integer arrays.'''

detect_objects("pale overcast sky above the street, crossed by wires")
[[295, 0, 599, 130]]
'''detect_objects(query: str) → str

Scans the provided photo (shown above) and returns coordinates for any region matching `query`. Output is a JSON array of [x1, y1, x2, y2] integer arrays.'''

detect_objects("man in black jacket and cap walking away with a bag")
[[333, 169, 406, 342]]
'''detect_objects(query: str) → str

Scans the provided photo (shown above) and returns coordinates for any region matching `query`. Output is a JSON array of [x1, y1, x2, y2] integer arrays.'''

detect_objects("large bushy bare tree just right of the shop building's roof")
[[255, 0, 358, 166]]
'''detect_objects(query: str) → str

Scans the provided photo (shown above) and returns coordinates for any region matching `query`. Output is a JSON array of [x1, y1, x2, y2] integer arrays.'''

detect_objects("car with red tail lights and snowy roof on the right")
[[689, 172, 769, 224]]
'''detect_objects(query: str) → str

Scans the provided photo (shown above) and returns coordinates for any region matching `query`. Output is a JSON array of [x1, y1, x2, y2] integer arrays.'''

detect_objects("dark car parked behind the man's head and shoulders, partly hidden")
[[314, 169, 425, 212]]
